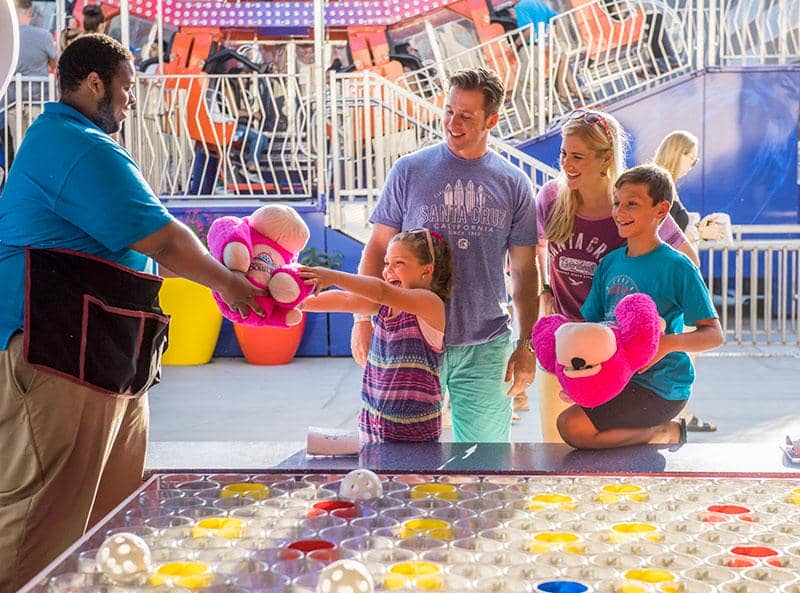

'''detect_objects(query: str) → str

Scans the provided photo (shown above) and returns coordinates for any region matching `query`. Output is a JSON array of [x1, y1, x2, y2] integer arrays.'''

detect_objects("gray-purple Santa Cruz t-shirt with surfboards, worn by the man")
[[370, 143, 537, 346]]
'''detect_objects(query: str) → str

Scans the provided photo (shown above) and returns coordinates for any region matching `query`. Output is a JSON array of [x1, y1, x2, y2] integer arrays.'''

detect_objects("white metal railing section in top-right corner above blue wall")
[[719, 0, 800, 65]]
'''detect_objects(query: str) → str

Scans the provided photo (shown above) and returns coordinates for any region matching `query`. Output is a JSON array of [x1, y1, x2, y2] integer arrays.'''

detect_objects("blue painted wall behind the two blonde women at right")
[[520, 67, 800, 224]]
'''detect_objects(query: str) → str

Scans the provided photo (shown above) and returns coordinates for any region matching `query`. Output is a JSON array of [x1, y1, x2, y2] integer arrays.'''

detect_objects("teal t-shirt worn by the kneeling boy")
[[581, 244, 717, 400]]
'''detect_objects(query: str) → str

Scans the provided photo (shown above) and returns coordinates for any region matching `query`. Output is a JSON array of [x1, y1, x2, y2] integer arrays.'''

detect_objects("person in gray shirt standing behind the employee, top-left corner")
[[7, 0, 56, 150]]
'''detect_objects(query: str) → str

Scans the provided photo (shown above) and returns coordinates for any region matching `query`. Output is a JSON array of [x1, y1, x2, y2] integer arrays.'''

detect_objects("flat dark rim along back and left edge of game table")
[[22, 443, 800, 592]]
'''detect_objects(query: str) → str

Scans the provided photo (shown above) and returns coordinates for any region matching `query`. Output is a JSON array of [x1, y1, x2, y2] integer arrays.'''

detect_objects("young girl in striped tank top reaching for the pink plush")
[[300, 229, 452, 442]]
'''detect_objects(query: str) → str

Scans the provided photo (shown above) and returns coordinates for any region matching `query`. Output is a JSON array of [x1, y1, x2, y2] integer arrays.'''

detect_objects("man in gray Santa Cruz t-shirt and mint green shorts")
[[352, 68, 538, 442]]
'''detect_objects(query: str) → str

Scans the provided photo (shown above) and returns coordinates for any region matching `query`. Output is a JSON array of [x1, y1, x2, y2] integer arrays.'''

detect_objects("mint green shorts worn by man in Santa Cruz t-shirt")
[[440, 332, 512, 443]]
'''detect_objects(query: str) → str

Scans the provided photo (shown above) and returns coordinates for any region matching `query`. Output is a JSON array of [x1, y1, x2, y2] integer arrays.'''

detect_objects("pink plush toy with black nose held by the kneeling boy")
[[531, 293, 663, 408]]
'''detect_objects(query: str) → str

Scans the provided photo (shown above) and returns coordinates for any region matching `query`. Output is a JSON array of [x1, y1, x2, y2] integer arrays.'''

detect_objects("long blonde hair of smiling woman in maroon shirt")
[[545, 110, 628, 243]]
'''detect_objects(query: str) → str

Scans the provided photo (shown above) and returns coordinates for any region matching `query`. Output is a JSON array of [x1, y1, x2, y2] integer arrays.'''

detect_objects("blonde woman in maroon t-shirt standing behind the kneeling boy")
[[536, 109, 699, 442]]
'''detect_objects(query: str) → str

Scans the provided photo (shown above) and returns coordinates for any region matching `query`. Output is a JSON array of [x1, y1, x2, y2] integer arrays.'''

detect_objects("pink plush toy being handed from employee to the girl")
[[208, 204, 314, 327]]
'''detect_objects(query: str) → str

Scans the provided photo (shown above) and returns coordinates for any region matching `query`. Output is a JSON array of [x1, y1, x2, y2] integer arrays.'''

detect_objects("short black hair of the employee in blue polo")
[[58, 33, 133, 95]]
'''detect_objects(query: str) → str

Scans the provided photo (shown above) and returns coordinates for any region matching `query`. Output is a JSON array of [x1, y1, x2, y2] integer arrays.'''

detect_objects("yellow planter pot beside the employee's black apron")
[[158, 278, 222, 366]]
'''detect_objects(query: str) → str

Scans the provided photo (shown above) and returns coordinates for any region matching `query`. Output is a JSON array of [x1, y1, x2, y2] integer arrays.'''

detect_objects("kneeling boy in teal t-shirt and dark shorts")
[[558, 165, 724, 449]]
